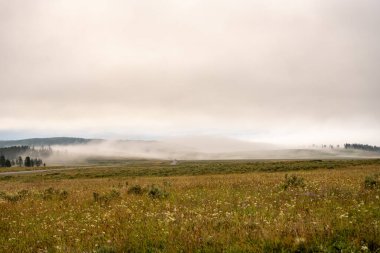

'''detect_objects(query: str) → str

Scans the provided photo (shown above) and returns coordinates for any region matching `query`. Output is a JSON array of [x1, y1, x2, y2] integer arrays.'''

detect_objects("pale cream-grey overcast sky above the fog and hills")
[[0, 0, 380, 145]]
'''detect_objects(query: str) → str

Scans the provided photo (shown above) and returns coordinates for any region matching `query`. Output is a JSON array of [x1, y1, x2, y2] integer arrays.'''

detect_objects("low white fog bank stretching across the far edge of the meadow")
[[42, 137, 380, 164]]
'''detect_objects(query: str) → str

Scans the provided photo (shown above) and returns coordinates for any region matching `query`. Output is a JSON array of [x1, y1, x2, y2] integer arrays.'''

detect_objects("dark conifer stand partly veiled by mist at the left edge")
[[0, 146, 53, 167]]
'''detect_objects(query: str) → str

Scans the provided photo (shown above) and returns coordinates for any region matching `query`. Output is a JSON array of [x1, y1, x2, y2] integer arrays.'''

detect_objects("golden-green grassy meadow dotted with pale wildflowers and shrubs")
[[0, 160, 380, 252]]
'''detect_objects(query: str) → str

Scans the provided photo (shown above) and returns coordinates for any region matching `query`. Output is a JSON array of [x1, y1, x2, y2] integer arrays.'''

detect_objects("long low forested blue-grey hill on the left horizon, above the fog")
[[0, 137, 99, 147]]
